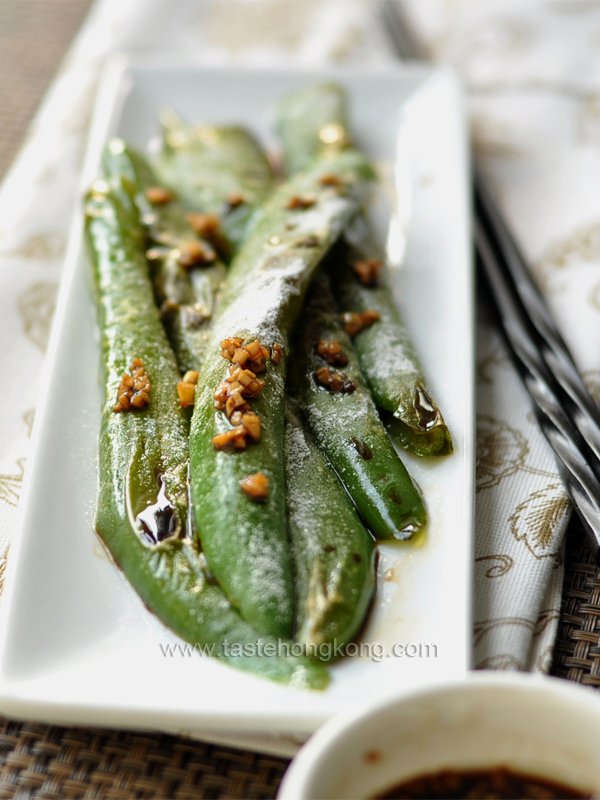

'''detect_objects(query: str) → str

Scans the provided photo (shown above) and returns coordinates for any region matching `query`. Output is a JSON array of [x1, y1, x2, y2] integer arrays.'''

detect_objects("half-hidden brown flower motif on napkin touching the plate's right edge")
[[476, 414, 529, 492]]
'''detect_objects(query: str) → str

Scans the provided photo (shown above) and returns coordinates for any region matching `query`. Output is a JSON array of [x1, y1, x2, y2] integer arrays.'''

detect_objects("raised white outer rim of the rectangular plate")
[[0, 54, 475, 735]]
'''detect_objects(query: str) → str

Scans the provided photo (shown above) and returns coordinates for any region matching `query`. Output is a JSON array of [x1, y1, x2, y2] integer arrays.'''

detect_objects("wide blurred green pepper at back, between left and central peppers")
[[155, 112, 275, 255]]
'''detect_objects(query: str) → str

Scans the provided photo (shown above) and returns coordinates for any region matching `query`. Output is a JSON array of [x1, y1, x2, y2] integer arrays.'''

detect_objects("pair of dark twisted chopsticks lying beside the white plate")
[[380, 0, 600, 566]]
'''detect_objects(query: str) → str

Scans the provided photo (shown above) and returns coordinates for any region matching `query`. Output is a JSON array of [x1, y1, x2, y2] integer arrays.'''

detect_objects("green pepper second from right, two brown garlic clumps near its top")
[[290, 275, 427, 540]]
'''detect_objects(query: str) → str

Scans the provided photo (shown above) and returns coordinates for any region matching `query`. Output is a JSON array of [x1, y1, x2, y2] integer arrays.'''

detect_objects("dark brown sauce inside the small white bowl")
[[374, 767, 593, 800]]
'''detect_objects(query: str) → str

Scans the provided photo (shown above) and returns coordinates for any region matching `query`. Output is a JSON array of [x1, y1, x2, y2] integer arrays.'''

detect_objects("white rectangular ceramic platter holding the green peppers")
[[0, 64, 474, 737]]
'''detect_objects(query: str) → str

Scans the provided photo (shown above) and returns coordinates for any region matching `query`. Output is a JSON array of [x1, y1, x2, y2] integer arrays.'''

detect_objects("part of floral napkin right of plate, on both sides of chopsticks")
[[409, 0, 600, 671]]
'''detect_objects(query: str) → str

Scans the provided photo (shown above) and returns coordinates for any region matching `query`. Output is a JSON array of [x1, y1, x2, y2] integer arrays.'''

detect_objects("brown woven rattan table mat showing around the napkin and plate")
[[0, 0, 600, 800]]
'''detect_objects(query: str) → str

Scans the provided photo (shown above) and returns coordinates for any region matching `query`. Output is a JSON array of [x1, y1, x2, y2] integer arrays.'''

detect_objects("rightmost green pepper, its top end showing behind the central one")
[[278, 83, 452, 456]]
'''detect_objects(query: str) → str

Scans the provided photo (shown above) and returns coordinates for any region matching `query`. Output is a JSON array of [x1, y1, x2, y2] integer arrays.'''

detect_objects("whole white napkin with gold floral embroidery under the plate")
[[0, 0, 600, 753]]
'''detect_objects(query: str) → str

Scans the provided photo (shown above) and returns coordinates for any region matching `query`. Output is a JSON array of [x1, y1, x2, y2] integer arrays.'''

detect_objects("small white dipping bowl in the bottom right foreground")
[[278, 672, 600, 800]]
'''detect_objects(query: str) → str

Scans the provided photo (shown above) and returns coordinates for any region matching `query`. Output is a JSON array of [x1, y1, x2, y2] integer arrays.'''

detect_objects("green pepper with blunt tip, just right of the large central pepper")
[[285, 400, 375, 661]]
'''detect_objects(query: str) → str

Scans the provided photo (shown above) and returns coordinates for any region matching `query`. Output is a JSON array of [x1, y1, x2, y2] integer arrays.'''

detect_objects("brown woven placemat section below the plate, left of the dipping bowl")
[[0, 720, 288, 800]]
